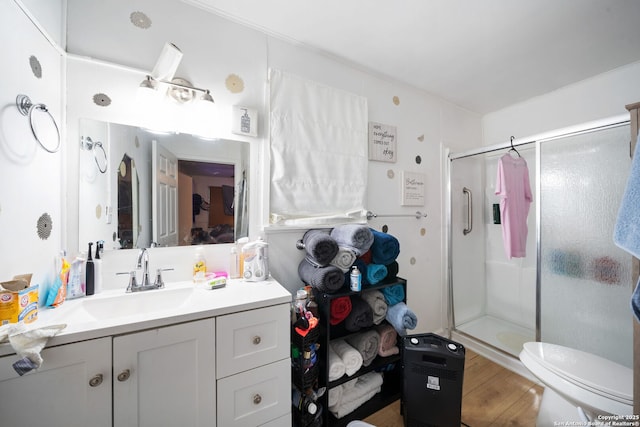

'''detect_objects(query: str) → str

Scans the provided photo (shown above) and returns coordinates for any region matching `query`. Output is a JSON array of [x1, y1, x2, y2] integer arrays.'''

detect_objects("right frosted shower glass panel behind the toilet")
[[540, 126, 633, 367]]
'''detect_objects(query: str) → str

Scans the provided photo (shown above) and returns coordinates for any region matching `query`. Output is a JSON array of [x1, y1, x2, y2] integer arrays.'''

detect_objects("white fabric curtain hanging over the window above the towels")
[[269, 69, 368, 225]]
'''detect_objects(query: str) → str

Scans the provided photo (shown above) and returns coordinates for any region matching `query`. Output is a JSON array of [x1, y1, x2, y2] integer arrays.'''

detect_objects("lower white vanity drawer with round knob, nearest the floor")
[[217, 359, 291, 427]]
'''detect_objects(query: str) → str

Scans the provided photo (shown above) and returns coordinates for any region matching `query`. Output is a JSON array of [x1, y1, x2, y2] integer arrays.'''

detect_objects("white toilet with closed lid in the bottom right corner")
[[520, 342, 633, 427]]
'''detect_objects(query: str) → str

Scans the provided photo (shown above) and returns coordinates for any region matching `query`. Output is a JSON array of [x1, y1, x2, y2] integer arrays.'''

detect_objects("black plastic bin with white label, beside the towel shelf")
[[402, 334, 465, 427]]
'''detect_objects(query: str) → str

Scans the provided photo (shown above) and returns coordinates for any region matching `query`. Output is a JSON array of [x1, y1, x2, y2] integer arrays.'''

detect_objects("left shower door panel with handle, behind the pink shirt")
[[450, 144, 536, 356]]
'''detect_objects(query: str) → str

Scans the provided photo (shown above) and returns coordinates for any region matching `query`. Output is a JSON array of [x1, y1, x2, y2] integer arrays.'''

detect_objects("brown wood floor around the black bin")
[[364, 349, 543, 427]]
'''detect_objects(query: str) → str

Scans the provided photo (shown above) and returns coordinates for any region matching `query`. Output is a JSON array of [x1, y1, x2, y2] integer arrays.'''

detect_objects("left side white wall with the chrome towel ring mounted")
[[0, 1, 67, 306]]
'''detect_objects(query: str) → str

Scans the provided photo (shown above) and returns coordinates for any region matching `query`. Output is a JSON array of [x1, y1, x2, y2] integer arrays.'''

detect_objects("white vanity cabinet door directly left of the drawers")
[[113, 319, 216, 427]]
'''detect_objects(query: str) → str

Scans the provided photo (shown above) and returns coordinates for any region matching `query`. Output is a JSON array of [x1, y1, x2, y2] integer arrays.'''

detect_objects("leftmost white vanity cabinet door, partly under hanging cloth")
[[0, 338, 111, 427]]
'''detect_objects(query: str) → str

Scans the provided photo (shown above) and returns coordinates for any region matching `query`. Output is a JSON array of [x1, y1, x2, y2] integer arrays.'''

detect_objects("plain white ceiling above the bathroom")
[[182, 0, 640, 114]]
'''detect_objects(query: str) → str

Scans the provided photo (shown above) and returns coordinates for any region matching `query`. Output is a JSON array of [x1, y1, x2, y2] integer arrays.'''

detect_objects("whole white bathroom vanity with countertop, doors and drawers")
[[0, 280, 291, 427]]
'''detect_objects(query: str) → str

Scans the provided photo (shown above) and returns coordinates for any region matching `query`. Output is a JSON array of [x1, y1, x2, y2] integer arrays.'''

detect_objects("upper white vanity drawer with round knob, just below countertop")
[[216, 304, 290, 378]]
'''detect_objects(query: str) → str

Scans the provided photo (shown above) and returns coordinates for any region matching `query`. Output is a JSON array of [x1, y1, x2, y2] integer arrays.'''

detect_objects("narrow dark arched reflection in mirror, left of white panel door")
[[118, 154, 138, 249]]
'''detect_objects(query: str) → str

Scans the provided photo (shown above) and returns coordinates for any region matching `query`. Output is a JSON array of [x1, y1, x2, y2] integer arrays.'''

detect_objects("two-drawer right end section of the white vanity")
[[216, 304, 291, 427]]
